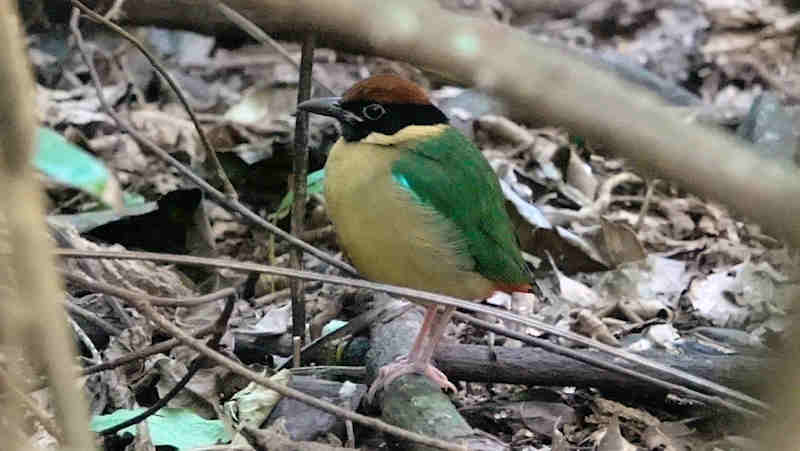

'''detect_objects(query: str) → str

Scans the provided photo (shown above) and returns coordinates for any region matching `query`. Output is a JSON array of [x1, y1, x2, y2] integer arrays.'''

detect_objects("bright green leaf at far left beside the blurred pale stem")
[[33, 127, 123, 208]]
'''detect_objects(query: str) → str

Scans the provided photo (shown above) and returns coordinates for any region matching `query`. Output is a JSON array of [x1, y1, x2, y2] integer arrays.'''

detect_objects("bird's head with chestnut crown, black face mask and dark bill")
[[297, 74, 447, 141]]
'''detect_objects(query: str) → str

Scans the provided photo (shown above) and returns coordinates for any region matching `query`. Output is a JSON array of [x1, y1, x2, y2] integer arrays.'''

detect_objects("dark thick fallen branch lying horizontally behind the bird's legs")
[[298, 314, 764, 404]]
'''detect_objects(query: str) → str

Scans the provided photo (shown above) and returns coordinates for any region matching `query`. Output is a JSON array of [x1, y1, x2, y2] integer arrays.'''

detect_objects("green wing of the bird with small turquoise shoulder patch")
[[392, 127, 531, 285]]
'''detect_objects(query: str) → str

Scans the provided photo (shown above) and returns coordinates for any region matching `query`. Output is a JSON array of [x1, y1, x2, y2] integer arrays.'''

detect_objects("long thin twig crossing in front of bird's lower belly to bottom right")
[[56, 249, 769, 414]]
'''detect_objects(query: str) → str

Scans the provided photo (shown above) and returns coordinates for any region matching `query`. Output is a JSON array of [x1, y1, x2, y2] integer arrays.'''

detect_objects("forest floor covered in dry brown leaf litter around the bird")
[[20, 0, 800, 451]]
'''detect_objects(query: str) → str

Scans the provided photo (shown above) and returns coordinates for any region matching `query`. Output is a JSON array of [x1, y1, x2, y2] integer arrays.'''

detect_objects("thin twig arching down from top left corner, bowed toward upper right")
[[70, 0, 239, 199]]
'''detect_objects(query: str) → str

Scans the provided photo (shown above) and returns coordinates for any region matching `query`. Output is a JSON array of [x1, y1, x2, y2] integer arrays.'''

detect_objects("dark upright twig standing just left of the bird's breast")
[[289, 33, 314, 348]]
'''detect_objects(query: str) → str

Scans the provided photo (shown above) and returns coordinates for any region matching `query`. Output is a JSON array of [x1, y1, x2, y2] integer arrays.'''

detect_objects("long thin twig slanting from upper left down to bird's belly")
[[71, 10, 358, 275]]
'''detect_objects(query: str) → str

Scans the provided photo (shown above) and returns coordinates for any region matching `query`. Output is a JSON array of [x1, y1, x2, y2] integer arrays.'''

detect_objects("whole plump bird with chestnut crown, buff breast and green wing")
[[297, 74, 531, 402]]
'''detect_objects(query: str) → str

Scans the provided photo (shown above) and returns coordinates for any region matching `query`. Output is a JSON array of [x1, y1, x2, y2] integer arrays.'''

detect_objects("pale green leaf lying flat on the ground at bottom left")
[[90, 407, 231, 451]]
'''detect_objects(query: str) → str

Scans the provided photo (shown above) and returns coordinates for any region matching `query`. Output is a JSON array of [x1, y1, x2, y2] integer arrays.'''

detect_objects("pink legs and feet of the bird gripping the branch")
[[367, 306, 457, 403]]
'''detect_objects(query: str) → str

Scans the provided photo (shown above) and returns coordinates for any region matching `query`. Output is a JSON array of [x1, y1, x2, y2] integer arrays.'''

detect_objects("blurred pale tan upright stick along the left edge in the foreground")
[[0, 2, 94, 450]]
